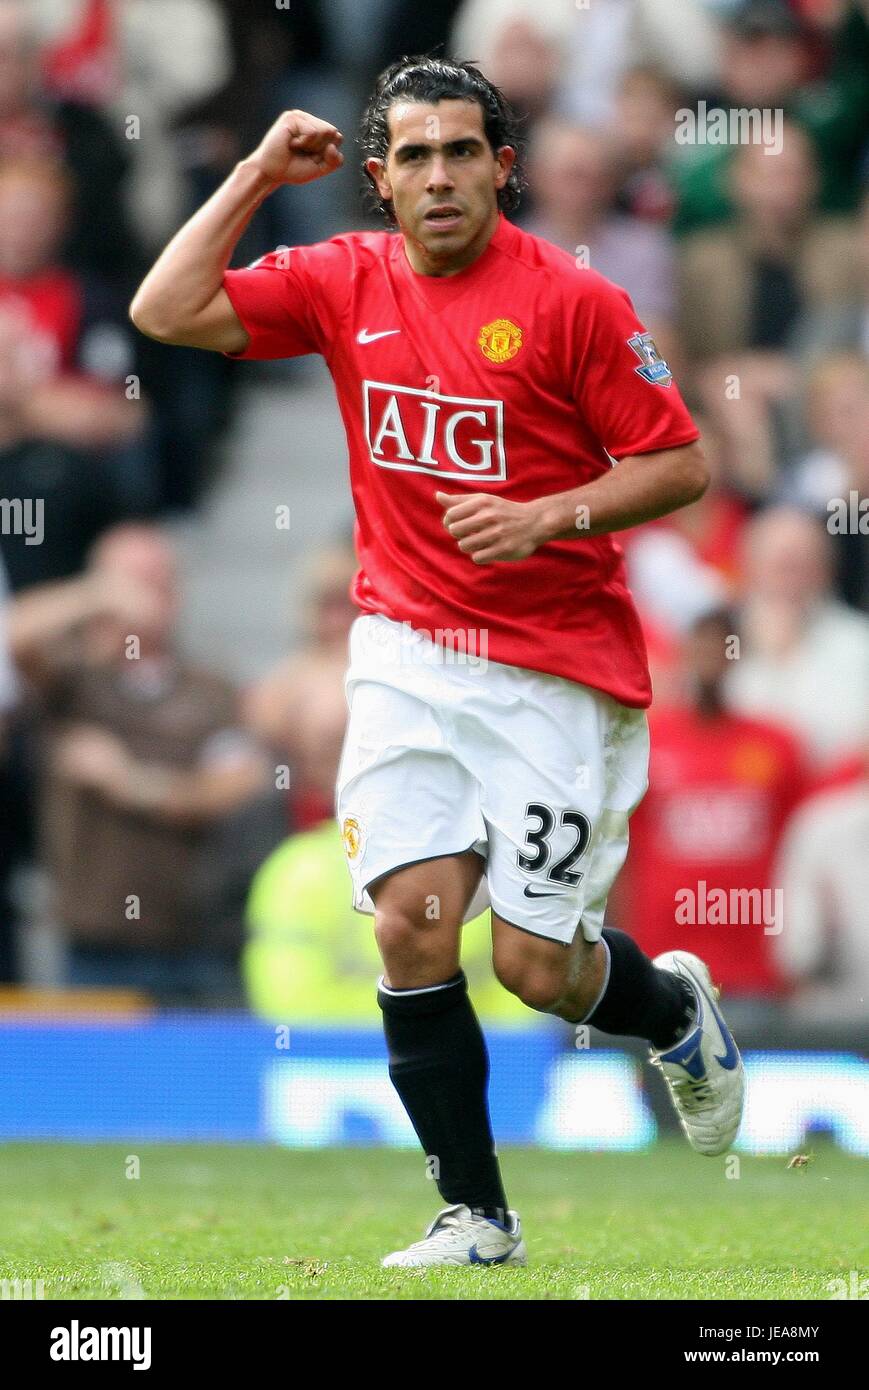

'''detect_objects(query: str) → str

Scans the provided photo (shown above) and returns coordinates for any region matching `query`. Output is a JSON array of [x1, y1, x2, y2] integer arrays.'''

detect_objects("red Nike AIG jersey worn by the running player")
[[224, 217, 698, 706]]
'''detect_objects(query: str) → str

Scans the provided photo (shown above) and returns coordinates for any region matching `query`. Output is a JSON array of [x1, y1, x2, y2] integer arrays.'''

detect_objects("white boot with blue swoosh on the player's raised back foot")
[[651, 951, 745, 1156]]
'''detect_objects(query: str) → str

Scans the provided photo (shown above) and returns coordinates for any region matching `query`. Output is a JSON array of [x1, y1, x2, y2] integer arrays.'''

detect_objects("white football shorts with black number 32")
[[336, 614, 648, 944]]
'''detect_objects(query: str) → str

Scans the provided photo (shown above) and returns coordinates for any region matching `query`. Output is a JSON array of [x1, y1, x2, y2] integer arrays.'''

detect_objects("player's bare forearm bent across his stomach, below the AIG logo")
[[435, 442, 709, 564]]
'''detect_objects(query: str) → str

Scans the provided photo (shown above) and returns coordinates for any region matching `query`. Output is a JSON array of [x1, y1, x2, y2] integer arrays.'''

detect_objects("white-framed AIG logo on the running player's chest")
[[362, 381, 507, 478]]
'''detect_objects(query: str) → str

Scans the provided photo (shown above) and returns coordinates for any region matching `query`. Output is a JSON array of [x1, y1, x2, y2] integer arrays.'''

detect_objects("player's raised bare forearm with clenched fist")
[[129, 111, 343, 352]]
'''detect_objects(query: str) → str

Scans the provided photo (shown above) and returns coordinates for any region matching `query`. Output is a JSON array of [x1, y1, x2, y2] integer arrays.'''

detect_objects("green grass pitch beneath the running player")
[[0, 1141, 869, 1300]]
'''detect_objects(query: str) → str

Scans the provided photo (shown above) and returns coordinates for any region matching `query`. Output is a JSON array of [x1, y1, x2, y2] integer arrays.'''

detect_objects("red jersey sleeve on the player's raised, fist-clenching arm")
[[224, 242, 349, 361]]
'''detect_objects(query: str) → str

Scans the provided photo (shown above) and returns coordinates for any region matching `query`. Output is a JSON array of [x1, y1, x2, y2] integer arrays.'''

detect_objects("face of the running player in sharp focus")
[[367, 100, 516, 275]]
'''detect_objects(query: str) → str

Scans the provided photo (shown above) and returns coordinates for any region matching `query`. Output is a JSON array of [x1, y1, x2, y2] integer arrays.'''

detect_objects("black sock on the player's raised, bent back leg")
[[583, 927, 695, 1051]]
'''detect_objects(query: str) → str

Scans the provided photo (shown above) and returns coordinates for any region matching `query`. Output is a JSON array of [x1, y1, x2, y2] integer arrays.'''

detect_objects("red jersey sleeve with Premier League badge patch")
[[569, 271, 699, 459]]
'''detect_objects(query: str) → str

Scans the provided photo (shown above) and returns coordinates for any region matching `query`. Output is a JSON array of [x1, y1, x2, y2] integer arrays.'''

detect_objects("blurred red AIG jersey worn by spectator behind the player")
[[627, 708, 805, 992]]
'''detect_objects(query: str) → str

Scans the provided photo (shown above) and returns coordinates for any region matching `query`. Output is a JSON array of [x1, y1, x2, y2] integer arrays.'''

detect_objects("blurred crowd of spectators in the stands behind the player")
[[0, 0, 869, 1022]]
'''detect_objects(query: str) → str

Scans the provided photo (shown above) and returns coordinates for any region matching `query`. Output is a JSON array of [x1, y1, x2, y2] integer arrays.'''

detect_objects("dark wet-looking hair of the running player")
[[359, 54, 526, 227]]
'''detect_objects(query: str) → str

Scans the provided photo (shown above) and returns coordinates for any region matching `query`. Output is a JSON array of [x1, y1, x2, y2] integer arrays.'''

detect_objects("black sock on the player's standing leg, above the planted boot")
[[377, 970, 507, 1222]]
